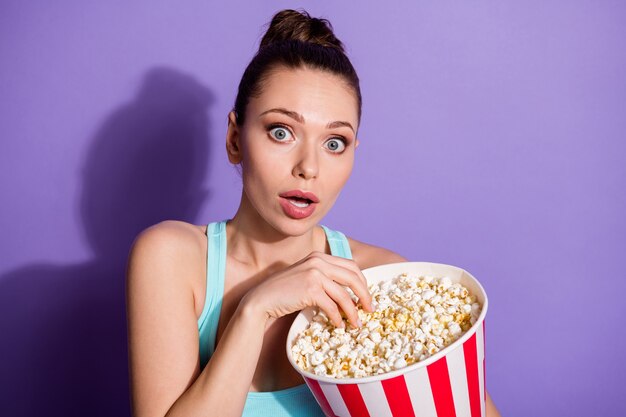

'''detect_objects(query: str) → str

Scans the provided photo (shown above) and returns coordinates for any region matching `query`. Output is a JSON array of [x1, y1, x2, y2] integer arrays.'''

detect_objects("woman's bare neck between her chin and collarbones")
[[226, 193, 326, 270]]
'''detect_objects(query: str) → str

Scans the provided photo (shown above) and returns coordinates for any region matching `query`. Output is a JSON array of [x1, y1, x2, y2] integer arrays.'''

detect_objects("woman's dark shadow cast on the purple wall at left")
[[0, 68, 212, 416]]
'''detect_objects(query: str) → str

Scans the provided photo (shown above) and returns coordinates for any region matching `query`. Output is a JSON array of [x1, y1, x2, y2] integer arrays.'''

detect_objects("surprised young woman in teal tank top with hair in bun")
[[127, 10, 497, 417]]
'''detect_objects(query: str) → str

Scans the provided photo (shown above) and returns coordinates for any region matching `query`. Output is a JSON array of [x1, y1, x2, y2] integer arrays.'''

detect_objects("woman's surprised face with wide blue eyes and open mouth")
[[229, 65, 358, 236]]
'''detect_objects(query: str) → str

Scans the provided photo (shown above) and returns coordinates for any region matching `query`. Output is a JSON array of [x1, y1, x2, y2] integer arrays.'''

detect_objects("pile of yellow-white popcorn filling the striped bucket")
[[291, 274, 481, 378]]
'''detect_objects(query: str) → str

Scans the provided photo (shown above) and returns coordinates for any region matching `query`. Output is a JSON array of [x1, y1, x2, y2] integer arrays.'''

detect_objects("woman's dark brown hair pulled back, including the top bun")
[[233, 9, 362, 126]]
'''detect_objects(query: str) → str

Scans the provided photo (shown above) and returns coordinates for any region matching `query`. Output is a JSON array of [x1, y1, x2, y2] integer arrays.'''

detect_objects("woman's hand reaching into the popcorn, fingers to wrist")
[[242, 252, 372, 327]]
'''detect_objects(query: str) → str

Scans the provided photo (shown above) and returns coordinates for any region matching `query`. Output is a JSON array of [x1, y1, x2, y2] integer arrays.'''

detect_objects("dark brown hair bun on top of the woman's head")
[[259, 9, 345, 53]]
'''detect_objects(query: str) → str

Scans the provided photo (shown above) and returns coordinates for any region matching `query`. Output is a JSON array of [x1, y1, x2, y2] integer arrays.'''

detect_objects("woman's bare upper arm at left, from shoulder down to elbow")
[[126, 220, 204, 415]]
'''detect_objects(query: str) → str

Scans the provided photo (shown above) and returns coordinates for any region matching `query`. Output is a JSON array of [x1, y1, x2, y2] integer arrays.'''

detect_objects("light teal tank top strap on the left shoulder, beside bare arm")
[[198, 221, 226, 368]]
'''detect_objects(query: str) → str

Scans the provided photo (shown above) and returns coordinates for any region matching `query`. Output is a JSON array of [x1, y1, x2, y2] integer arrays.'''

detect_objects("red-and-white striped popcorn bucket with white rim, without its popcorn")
[[287, 262, 488, 417]]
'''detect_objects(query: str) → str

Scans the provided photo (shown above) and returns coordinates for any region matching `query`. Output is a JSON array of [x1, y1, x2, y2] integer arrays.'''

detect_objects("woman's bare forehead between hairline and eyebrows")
[[248, 68, 358, 127]]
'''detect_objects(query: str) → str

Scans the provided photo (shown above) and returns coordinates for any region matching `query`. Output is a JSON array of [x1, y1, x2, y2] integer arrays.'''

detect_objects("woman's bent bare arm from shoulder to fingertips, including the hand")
[[127, 222, 371, 417]]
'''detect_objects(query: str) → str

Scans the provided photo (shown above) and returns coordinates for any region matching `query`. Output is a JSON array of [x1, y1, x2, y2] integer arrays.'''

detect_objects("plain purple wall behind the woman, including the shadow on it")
[[0, 1, 626, 416]]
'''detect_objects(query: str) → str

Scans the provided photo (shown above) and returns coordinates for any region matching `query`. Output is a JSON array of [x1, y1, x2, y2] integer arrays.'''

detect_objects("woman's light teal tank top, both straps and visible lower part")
[[198, 221, 352, 417]]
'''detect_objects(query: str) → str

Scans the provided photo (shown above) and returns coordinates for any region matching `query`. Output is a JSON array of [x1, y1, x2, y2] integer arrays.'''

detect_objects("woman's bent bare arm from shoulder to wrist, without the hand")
[[127, 222, 265, 417]]
